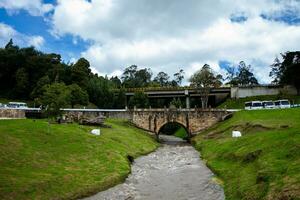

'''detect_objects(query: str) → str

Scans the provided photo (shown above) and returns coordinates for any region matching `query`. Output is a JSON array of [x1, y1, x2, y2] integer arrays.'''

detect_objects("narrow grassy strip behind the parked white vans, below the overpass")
[[218, 95, 300, 109]]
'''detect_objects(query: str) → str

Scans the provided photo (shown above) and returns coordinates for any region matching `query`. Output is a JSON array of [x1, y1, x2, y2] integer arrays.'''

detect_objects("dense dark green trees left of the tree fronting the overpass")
[[0, 40, 184, 114]]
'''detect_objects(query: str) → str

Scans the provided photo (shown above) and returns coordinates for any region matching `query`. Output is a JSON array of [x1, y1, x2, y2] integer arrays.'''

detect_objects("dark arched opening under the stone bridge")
[[158, 122, 189, 141]]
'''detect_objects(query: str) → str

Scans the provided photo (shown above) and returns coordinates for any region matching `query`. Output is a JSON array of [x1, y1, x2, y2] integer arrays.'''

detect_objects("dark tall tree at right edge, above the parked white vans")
[[270, 51, 300, 95]]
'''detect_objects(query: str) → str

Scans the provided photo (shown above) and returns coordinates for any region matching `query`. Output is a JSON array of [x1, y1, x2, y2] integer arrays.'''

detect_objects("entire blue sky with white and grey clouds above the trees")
[[0, 0, 300, 83]]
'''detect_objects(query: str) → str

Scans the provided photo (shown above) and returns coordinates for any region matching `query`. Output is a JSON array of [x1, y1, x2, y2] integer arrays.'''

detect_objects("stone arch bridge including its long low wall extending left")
[[62, 108, 231, 138]]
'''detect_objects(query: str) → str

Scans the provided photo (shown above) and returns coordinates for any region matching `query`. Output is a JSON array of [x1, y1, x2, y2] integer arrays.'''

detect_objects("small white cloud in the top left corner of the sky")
[[0, 0, 53, 16]]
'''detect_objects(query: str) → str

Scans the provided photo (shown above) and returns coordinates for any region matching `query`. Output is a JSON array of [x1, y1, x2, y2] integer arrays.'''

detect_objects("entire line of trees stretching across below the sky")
[[0, 40, 300, 113]]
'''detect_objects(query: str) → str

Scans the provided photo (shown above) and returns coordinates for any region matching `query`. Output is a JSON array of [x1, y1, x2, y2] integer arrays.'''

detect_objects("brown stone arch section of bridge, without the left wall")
[[131, 109, 231, 137]]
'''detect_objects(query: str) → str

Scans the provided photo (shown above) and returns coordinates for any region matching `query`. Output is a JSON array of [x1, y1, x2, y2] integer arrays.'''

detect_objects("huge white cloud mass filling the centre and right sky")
[[52, 0, 300, 83]]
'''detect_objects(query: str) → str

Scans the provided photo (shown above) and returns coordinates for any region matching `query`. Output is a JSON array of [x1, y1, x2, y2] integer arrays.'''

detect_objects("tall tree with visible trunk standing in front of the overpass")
[[190, 64, 222, 108]]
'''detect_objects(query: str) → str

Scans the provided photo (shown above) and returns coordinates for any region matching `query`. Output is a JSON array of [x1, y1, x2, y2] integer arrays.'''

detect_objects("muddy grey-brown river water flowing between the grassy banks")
[[86, 136, 225, 200]]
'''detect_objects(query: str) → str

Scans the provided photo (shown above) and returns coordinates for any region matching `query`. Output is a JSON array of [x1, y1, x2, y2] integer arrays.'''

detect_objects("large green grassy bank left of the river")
[[0, 120, 158, 199]]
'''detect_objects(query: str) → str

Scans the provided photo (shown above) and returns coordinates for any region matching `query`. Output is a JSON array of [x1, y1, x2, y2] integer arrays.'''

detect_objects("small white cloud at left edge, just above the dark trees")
[[0, 23, 45, 49]]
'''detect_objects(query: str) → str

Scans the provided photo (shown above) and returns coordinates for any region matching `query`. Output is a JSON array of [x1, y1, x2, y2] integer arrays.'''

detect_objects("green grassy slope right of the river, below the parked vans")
[[193, 108, 300, 200]]
